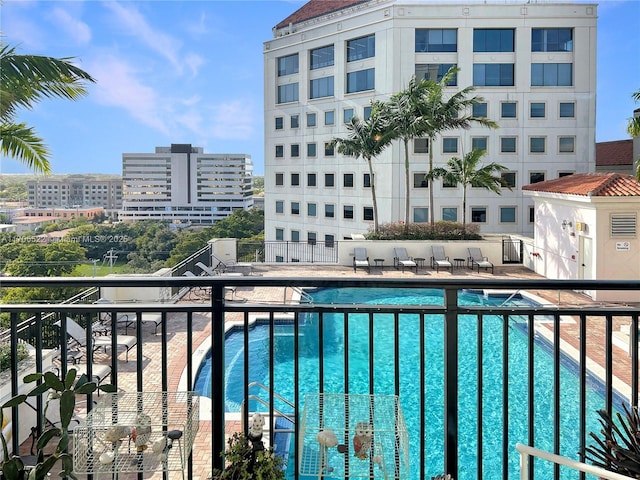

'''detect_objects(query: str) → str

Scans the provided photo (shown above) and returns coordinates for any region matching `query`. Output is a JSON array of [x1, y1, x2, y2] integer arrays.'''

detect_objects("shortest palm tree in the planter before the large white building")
[[428, 149, 511, 228]]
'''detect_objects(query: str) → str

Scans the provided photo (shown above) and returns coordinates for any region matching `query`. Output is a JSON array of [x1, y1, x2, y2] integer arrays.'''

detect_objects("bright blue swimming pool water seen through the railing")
[[195, 288, 616, 480]]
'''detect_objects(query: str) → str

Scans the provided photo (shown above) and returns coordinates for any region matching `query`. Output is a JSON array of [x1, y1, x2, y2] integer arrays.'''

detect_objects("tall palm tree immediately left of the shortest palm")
[[417, 67, 498, 225]]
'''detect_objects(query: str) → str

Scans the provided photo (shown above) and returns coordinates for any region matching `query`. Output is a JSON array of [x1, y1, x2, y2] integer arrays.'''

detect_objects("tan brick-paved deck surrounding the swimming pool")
[[40, 264, 631, 480]]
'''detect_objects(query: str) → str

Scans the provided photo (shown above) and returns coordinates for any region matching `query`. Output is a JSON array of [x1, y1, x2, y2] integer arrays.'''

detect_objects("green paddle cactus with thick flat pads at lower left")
[[0, 368, 115, 480]]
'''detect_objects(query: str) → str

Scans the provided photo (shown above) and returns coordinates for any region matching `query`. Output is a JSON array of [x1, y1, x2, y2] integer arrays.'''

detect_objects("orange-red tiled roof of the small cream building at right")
[[522, 173, 640, 197]]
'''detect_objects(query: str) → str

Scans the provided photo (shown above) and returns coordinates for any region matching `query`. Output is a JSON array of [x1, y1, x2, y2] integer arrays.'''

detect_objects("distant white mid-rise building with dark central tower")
[[119, 144, 253, 226]]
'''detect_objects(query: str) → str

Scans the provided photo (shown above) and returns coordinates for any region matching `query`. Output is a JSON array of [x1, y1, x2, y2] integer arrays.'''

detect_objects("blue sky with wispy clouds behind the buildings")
[[0, 0, 640, 175]]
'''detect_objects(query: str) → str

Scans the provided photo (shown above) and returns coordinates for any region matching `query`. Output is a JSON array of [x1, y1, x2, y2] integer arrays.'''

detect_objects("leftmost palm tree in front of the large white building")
[[333, 102, 392, 233]]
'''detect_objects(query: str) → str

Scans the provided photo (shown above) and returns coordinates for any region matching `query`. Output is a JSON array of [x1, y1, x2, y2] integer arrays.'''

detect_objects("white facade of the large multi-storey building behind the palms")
[[264, 0, 597, 242]]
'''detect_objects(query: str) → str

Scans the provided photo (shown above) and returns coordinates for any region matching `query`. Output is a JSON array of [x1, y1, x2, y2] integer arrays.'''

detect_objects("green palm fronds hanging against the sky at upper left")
[[0, 43, 95, 173]]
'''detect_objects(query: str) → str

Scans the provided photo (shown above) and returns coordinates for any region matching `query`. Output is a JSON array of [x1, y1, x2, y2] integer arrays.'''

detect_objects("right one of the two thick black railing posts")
[[444, 287, 458, 478]]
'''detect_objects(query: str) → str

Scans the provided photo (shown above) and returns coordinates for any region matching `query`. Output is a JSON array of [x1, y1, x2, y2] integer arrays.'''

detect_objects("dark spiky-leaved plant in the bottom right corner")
[[585, 404, 640, 478]]
